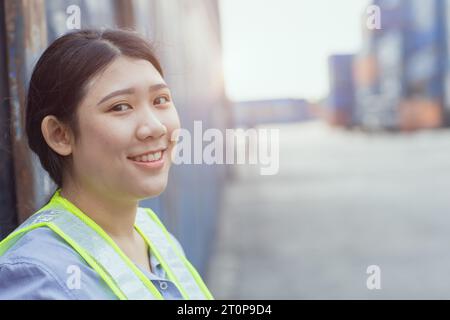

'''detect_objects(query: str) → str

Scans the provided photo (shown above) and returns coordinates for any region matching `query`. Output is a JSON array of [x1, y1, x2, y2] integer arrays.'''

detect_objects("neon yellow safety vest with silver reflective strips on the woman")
[[0, 189, 213, 300]]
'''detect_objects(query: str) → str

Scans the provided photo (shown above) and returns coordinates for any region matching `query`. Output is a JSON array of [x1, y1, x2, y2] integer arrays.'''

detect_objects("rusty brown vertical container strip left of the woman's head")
[[5, 0, 47, 223]]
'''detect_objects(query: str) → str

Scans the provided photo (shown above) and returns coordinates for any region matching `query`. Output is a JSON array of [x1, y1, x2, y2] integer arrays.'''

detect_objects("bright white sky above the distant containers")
[[220, 0, 370, 101]]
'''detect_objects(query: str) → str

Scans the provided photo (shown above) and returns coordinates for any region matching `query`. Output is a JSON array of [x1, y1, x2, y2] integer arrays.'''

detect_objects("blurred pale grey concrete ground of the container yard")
[[206, 122, 450, 299]]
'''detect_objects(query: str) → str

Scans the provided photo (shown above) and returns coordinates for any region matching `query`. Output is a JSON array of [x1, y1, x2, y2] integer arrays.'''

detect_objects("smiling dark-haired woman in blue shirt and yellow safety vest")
[[0, 30, 212, 299]]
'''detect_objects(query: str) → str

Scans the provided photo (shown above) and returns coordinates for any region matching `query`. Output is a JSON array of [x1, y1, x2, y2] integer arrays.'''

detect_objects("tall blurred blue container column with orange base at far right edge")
[[400, 0, 445, 130]]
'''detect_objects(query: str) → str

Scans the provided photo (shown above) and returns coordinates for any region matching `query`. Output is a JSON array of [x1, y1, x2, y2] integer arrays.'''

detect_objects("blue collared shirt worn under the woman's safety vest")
[[0, 227, 184, 300]]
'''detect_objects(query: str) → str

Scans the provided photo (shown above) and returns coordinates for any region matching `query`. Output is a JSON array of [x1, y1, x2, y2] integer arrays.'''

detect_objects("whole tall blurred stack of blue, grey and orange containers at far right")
[[329, 0, 450, 131]]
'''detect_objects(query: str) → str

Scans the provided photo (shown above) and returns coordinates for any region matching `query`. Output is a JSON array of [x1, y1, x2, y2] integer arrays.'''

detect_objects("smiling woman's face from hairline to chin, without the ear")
[[67, 57, 180, 200]]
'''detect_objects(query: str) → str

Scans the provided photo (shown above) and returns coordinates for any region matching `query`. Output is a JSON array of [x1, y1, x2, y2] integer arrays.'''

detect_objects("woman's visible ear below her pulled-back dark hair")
[[41, 116, 72, 156]]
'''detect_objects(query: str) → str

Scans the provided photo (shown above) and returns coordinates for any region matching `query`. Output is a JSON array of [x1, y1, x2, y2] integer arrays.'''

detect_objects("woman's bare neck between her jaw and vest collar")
[[60, 184, 138, 239]]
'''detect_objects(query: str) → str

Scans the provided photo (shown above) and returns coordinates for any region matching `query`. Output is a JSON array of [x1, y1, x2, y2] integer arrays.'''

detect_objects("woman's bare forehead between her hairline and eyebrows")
[[86, 56, 165, 99]]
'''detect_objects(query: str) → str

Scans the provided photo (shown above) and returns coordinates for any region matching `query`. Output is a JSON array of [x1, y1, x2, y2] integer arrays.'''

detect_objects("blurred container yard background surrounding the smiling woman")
[[0, 0, 450, 299]]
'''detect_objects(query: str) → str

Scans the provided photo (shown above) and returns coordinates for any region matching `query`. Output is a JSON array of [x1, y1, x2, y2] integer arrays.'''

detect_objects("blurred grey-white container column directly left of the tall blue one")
[[353, 0, 407, 130]]
